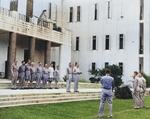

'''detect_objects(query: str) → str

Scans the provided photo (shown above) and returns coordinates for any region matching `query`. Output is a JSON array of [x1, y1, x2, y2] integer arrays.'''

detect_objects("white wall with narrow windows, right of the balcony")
[[63, 0, 140, 83]]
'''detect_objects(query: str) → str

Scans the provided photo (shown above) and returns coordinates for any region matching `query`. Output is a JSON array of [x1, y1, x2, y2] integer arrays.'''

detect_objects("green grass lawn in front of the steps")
[[0, 96, 150, 119]]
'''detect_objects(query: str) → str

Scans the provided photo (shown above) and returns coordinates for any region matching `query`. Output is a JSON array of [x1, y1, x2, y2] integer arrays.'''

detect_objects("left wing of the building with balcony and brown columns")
[[0, 0, 72, 78]]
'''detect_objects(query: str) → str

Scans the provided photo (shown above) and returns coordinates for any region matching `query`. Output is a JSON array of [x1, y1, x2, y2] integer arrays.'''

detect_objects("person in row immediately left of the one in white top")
[[42, 64, 48, 89]]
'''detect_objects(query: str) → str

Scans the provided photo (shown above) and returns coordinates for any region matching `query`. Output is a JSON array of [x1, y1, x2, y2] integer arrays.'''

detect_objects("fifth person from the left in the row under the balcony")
[[36, 62, 42, 89]]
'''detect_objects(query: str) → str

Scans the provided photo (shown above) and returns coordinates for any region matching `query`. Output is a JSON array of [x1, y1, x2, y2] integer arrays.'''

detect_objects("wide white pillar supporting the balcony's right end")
[[59, 45, 71, 80]]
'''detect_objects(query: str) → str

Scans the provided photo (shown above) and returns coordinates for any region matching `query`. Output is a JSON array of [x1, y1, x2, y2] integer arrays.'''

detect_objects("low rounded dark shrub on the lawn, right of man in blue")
[[115, 86, 132, 99]]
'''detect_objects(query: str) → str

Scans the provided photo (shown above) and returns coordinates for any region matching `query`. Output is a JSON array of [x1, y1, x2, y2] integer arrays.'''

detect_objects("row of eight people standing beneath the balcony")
[[11, 59, 59, 89]]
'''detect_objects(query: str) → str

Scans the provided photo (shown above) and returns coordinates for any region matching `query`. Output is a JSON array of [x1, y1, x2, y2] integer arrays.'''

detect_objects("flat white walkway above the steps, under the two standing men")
[[0, 89, 102, 95]]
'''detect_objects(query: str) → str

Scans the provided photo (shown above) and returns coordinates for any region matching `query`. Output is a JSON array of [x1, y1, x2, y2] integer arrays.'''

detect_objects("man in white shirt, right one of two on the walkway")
[[73, 63, 82, 92]]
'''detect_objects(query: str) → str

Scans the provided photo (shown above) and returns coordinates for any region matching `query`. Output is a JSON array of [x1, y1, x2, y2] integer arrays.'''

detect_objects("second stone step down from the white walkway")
[[0, 95, 100, 107]]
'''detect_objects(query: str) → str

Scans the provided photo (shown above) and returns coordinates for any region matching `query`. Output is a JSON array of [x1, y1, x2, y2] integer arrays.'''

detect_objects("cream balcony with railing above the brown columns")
[[0, 7, 72, 46]]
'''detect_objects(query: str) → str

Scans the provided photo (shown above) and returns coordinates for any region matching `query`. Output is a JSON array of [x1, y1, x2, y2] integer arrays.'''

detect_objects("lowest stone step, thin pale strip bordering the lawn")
[[0, 98, 100, 108]]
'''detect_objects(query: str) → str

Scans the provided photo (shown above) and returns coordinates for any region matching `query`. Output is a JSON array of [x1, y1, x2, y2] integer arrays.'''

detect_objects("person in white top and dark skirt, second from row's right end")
[[48, 63, 54, 89]]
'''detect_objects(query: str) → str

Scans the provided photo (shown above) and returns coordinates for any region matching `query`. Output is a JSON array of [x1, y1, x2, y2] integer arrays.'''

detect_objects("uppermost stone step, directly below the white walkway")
[[0, 93, 100, 102]]
